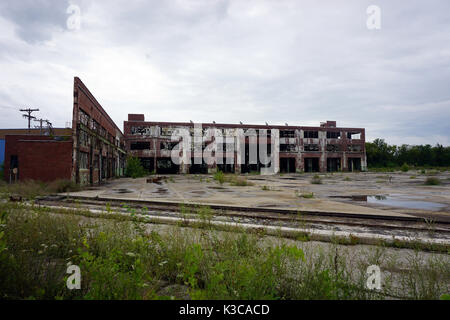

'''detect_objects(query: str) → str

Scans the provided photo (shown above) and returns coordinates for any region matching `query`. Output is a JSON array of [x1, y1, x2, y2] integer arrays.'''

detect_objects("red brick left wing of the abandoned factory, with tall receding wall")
[[0, 77, 127, 185]]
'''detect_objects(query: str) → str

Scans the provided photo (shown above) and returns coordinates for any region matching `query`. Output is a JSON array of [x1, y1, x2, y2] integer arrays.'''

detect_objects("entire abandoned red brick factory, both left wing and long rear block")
[[0, 77, 366, 185]]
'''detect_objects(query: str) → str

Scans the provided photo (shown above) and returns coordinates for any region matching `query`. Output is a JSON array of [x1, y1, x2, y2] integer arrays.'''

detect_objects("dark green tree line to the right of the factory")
[[366, 139, 450, 168]]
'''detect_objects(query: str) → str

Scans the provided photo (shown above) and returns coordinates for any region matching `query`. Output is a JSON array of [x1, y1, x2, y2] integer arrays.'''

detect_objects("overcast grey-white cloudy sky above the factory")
[[0, 0, 450, 145]]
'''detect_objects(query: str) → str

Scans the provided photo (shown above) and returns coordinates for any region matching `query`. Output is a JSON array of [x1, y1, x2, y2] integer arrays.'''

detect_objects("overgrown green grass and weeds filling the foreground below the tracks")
[[0, 203, 450, 299]]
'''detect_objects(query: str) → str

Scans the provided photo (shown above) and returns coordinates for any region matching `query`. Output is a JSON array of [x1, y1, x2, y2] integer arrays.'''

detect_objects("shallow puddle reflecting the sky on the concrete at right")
[[330, 195, 446, 211]]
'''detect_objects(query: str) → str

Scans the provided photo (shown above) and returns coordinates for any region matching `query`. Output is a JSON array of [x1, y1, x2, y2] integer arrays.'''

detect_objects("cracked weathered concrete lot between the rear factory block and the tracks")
[[63, 173, 450, 218]]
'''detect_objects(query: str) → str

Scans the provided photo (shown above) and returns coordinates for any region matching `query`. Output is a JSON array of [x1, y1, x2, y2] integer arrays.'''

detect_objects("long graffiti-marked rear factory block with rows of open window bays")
[[124, 114, 366, 173]]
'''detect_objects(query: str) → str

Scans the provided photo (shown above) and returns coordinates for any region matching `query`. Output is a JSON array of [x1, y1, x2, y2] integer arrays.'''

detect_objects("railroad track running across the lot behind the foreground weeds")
[[36, 196, 450, 248]]
